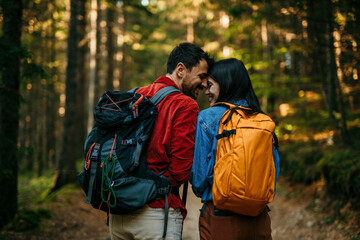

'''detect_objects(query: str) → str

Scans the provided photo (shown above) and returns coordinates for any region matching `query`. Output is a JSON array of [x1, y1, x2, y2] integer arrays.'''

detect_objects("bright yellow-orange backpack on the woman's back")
[[212, 103, 275, 216]]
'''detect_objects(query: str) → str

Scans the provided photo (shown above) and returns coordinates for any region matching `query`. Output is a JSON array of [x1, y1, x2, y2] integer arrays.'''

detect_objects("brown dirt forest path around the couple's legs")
[[0, 179, 360, 240]]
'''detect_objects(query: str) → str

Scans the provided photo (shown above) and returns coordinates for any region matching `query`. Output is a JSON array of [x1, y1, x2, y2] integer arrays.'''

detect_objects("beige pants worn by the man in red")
[[109, 205, 183, 240]]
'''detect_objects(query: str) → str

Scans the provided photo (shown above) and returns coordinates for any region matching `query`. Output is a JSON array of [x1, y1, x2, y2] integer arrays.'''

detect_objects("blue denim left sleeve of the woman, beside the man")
[[190, 116, 211, 197]]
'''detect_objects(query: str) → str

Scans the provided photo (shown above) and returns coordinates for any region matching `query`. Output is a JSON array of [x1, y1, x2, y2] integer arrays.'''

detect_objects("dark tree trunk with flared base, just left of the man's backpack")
[[51, 0, 80, 192]]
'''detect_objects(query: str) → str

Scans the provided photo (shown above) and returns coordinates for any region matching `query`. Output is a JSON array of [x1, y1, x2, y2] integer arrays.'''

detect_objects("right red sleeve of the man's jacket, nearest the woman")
[[165, 103, 199, 186]]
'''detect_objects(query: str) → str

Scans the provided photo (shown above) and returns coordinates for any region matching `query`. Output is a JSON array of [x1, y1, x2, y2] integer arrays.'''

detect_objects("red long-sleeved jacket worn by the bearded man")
[[136, 77, 199, 218]]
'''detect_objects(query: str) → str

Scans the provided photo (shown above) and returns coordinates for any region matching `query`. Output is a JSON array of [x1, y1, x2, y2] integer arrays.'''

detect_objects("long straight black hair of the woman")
[[208, 58, 263, 114]]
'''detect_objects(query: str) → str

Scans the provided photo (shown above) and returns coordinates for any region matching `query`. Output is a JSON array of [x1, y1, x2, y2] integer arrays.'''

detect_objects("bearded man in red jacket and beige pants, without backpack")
[[109, 43, 213, 240]]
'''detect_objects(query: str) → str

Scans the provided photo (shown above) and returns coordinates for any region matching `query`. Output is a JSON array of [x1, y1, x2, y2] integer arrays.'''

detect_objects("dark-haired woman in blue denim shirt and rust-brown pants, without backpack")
[[190, 58, 279, 240]]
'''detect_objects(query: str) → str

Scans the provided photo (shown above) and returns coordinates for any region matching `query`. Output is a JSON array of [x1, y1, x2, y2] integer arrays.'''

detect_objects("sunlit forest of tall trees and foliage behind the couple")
[[0, 0, 360, 239]]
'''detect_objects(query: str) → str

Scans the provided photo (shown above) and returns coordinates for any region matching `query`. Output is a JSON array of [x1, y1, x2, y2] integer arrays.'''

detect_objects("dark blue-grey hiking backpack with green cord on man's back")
[[78, 87, 180, 214]]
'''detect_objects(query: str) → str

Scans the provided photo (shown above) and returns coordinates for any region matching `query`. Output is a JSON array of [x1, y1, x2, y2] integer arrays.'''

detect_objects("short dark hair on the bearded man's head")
[[166, 42, 214, 74]]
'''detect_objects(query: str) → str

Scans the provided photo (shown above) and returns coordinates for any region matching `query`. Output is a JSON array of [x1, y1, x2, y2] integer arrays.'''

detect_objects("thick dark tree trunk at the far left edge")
[[0, 0, 22, 228]]
